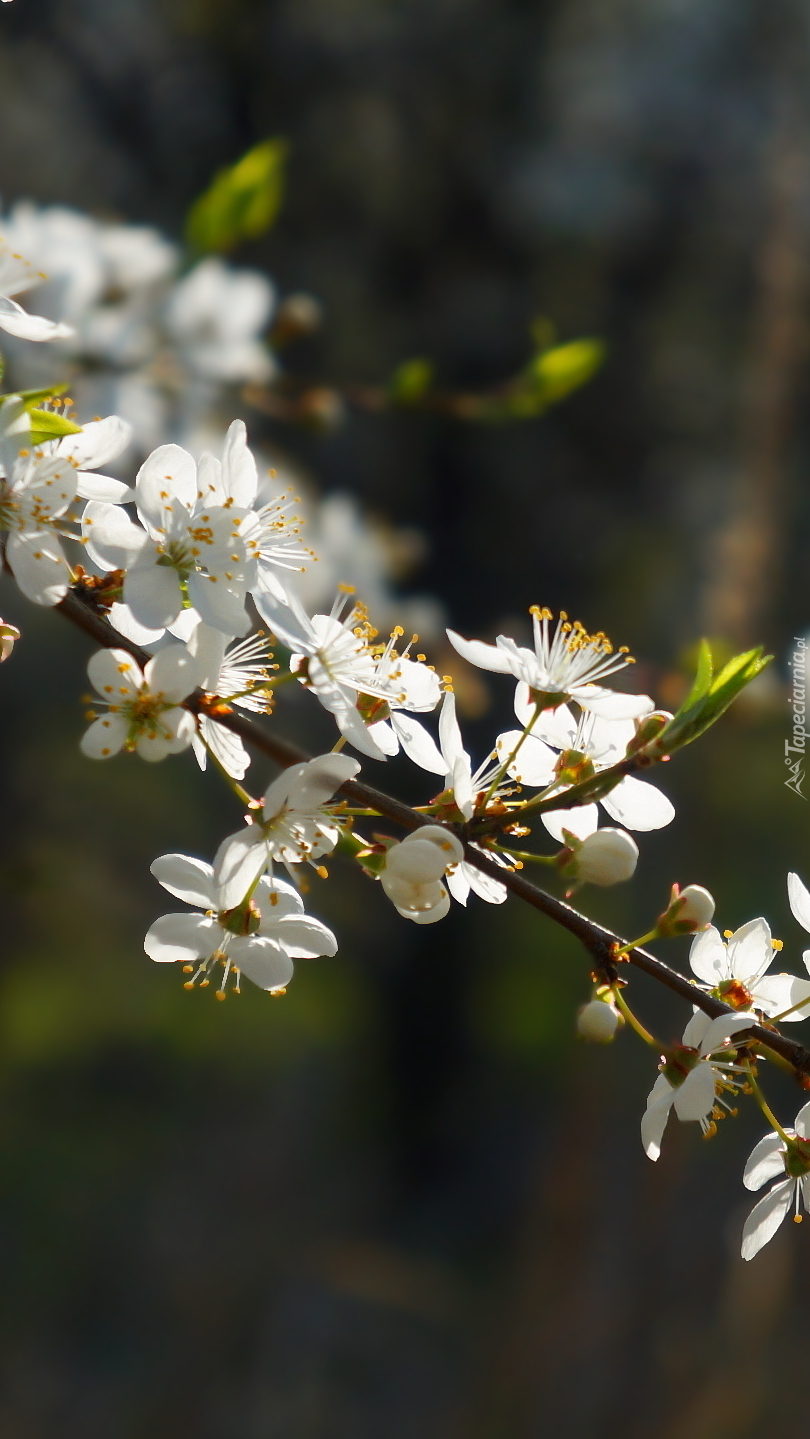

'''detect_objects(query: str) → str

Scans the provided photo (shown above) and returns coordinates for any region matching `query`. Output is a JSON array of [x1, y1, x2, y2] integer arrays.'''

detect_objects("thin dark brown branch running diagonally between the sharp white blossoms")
[[56, 591, 810, 1076]]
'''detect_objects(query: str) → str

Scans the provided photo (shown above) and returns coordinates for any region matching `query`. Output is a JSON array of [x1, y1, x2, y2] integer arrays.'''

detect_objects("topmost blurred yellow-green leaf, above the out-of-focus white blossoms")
[[186, 140, 288, 255]]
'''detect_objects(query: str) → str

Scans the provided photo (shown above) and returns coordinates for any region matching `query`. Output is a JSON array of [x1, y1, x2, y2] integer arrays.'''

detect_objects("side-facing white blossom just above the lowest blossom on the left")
[[214, 754, 360, 908]]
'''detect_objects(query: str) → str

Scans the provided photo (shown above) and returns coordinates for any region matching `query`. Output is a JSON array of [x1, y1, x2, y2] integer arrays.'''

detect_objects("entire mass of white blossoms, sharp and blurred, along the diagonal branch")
[[0, 182, 810, 1259]]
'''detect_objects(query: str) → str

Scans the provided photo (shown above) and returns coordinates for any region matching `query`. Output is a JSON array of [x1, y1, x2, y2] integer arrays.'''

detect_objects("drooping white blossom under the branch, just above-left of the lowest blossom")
[[642, 1010, 751, 1160]]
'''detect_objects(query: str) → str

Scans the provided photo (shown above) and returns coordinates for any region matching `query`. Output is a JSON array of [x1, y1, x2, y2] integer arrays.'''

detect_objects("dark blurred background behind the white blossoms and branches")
[[0, 0, 810, 1439]]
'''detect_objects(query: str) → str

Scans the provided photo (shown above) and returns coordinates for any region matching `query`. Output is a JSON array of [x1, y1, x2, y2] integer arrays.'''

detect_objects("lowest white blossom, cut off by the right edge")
[[742, 1104, 810, 1259]]
